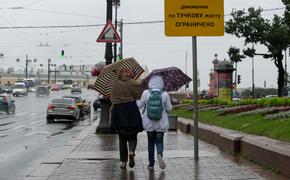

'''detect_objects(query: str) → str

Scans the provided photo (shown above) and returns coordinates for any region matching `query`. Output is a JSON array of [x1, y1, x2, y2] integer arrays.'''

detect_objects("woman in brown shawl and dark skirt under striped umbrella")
[[110, 69, 143, 169]]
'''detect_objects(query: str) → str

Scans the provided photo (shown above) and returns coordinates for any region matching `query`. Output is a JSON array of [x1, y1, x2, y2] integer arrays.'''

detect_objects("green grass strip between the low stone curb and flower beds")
[[171, 109, 290, 142]]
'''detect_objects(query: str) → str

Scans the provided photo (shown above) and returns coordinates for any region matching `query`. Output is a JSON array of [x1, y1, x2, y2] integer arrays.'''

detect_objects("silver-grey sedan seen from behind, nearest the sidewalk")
[[46, 98, 80, 123]]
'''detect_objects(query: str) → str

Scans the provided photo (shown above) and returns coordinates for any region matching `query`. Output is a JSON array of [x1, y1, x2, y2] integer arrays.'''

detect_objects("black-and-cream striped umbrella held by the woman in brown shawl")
[[91, 57, 144, 96]]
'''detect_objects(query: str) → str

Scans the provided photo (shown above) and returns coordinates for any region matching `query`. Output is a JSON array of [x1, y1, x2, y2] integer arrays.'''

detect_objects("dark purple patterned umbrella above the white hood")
[[141, 67, 191, 91]]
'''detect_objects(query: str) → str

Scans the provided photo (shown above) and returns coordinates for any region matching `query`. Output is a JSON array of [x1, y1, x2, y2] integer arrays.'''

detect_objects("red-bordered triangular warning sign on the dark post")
[[97, 20, 121, 43]]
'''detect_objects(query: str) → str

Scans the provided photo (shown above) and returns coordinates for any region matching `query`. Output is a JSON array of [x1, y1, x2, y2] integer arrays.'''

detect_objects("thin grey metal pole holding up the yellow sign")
[[192, 36, 198, 160]]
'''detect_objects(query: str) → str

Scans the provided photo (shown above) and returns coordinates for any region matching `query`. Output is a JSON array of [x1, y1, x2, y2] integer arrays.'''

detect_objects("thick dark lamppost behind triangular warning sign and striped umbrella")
[[96, 0, 113, 134]]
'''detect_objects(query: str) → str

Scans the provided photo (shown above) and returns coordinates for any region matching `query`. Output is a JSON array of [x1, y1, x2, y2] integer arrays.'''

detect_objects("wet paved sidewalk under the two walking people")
[[25, 119, 286, 180]]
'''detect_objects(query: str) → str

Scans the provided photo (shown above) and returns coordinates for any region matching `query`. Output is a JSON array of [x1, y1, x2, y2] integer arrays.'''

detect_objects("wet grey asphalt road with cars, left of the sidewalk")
[[0, 89, 99, 180]]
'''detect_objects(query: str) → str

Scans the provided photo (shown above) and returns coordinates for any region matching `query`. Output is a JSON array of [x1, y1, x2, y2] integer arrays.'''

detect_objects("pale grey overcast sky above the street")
[[0, 0, 290, 89]]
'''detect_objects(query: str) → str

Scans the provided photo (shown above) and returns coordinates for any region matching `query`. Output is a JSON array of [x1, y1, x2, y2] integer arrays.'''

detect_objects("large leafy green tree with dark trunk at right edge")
[[225, 5, 290, 96]]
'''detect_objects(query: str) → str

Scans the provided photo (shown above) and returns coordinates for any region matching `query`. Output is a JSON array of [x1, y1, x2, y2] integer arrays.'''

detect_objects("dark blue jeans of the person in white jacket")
[[147, 131, 164, 166]]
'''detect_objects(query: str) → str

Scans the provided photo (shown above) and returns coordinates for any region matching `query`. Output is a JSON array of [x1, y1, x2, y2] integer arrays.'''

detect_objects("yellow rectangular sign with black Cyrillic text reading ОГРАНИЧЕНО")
[[164, 0, 224, 36]]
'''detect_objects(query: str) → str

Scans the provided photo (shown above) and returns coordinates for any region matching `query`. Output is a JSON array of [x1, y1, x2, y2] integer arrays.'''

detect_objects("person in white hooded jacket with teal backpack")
[[137, 75, 172, 170]]
